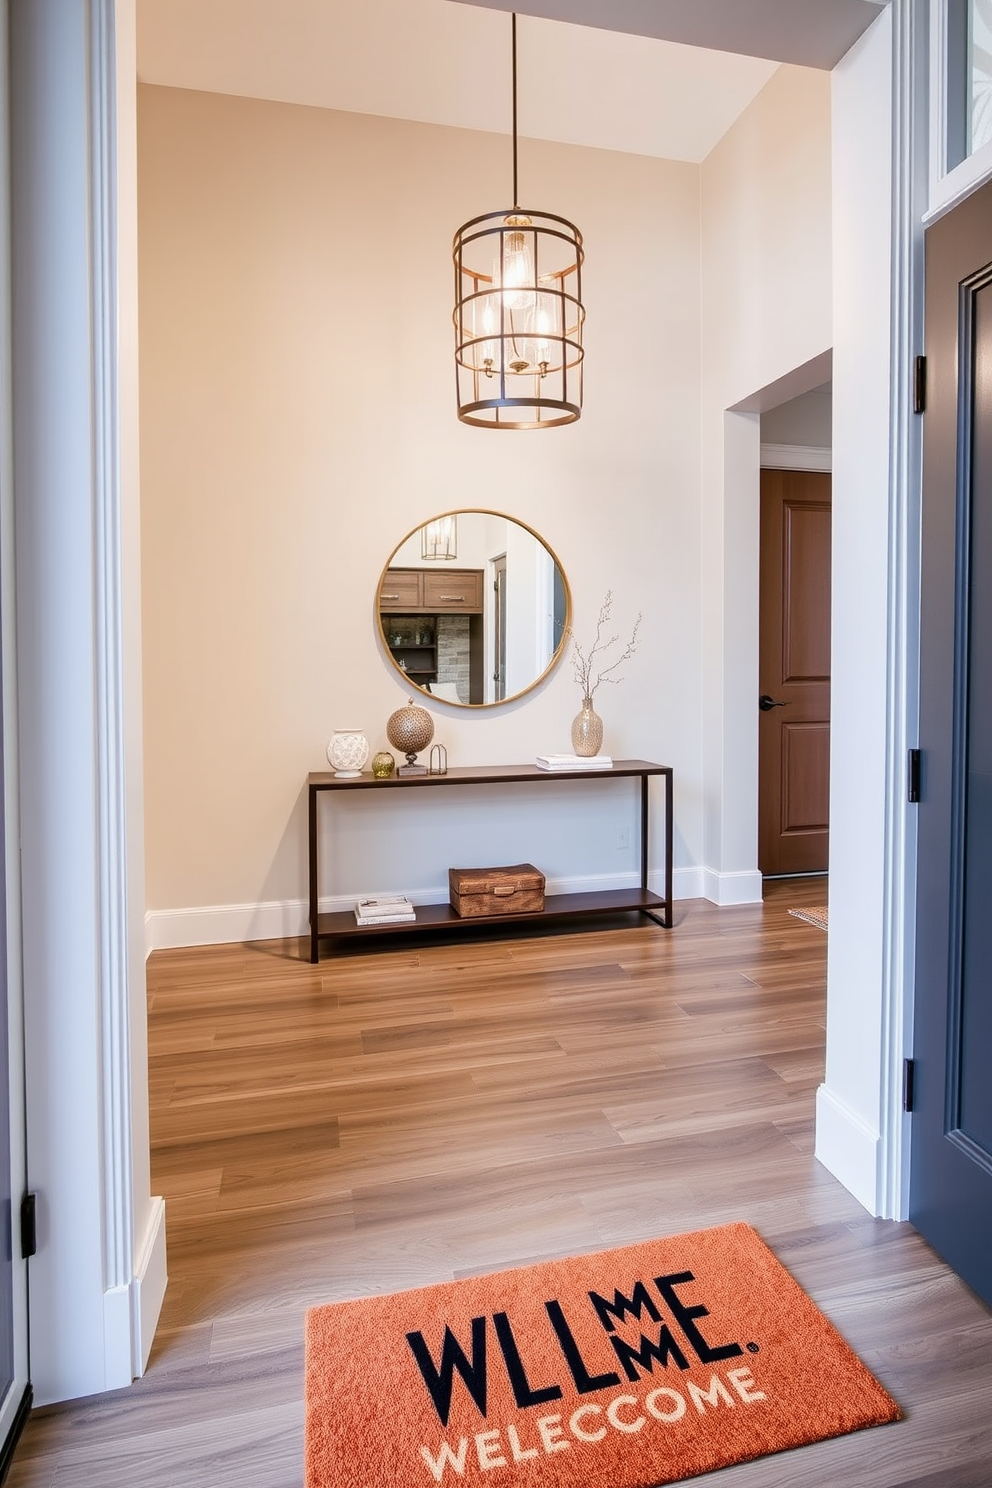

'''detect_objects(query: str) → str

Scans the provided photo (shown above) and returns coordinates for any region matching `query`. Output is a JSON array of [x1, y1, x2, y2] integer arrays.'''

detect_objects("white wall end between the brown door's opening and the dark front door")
[[817, 10, 892, 1213]]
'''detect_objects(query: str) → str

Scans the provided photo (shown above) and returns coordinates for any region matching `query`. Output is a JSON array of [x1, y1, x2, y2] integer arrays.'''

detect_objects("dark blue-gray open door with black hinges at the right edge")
[[910, 171, 992, 1302]]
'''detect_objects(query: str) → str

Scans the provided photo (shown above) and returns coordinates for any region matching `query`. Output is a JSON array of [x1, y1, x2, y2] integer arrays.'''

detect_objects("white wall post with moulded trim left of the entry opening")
[[10, 0, 165, 1403]]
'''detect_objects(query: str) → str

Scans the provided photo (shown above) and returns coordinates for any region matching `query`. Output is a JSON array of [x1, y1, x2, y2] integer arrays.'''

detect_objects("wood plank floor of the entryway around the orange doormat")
[[9, 879, 992, 1488]]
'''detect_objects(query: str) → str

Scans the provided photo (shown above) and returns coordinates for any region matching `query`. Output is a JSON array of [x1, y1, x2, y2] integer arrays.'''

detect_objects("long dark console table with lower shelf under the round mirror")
[[308, 759, 674, 961]]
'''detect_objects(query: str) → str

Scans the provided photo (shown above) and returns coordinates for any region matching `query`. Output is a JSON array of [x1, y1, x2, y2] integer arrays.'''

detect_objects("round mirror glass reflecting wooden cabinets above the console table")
[[378, 512, 570, 707]]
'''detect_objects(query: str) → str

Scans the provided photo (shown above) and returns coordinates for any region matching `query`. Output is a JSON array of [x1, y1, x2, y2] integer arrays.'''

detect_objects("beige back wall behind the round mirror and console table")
[[138, 86, 702, 939]]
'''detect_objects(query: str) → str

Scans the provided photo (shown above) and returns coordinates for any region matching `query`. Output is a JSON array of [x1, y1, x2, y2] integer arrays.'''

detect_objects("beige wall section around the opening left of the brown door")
[[700, 67, 833, 902]]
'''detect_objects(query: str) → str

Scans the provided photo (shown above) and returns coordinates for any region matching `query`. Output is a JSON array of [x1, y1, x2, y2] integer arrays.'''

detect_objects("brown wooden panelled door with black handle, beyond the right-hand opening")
[[756, 470, 830, 875]]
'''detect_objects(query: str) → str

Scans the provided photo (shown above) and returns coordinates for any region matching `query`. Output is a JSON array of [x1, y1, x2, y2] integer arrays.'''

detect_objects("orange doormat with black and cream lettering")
[[305, 1225, 900, 1488]]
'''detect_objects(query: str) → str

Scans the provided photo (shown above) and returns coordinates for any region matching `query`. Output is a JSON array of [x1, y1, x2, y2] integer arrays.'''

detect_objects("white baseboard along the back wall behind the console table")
[[144, 868, 713, 955]]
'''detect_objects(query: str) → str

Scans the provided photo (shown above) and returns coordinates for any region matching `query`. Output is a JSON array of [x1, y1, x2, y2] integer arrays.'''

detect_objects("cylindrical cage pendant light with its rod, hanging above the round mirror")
[[452, 13, 586, 429]]
